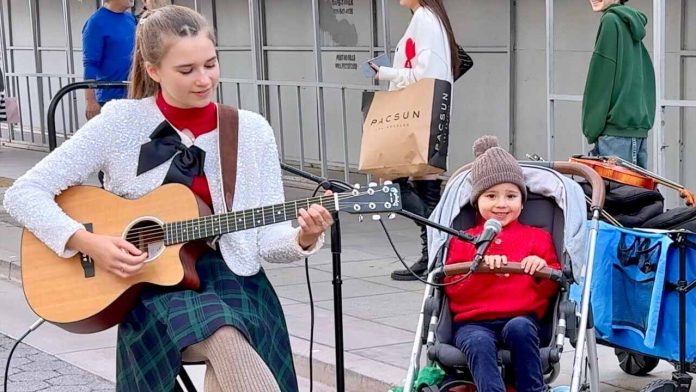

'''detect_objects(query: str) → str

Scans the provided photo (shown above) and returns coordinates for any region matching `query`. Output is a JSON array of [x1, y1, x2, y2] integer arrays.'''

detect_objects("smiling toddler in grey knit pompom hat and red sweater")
[[445, 136, 561, 392]]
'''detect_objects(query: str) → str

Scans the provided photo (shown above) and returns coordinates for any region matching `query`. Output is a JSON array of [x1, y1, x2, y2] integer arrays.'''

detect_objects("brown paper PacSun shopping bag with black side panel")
[[359, 79, 452, 179]]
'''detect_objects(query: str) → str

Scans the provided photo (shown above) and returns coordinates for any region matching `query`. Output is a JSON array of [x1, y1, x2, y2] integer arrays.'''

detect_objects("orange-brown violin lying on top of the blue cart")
[[570, 155, 696, 207]]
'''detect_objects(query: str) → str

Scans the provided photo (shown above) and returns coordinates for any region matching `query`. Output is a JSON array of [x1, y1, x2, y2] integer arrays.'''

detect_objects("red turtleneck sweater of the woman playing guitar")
[[157, 94, 217, 207]]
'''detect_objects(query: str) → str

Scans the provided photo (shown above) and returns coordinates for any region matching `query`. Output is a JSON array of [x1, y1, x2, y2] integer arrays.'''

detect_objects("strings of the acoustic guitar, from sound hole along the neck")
[[126, 191, 392, 242]]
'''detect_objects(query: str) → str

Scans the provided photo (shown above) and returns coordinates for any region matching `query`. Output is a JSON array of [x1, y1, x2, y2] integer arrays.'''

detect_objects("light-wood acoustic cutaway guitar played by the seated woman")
[[21, 184, 401, 333]]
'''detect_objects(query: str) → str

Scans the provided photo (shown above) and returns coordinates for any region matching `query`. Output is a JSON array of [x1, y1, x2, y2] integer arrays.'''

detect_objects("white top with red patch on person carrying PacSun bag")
[[378, 6, 453, 91]]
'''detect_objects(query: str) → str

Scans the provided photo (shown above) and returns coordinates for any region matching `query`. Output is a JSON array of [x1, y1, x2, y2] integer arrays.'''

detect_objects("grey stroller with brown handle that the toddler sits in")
[[396, 162, 604, 392]]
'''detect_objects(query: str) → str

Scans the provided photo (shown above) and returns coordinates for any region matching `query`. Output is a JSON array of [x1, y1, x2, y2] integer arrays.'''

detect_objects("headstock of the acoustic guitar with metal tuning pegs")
[[338, 182, 401, 214]]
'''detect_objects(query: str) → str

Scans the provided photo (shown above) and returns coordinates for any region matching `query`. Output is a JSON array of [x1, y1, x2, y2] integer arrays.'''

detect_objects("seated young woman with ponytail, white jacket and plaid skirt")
[[5, 6, 332, 392]]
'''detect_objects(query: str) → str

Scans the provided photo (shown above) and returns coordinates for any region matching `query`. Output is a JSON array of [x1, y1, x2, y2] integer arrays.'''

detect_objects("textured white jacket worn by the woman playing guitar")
[[4, 97, 323, 276]]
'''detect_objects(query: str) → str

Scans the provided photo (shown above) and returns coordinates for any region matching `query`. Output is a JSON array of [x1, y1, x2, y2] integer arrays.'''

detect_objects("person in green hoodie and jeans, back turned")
[[582, 0, 656, 168]]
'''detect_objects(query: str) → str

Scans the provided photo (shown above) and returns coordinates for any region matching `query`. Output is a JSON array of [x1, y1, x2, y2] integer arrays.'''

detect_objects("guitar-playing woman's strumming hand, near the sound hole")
[[67, 230, 147, 278]]
